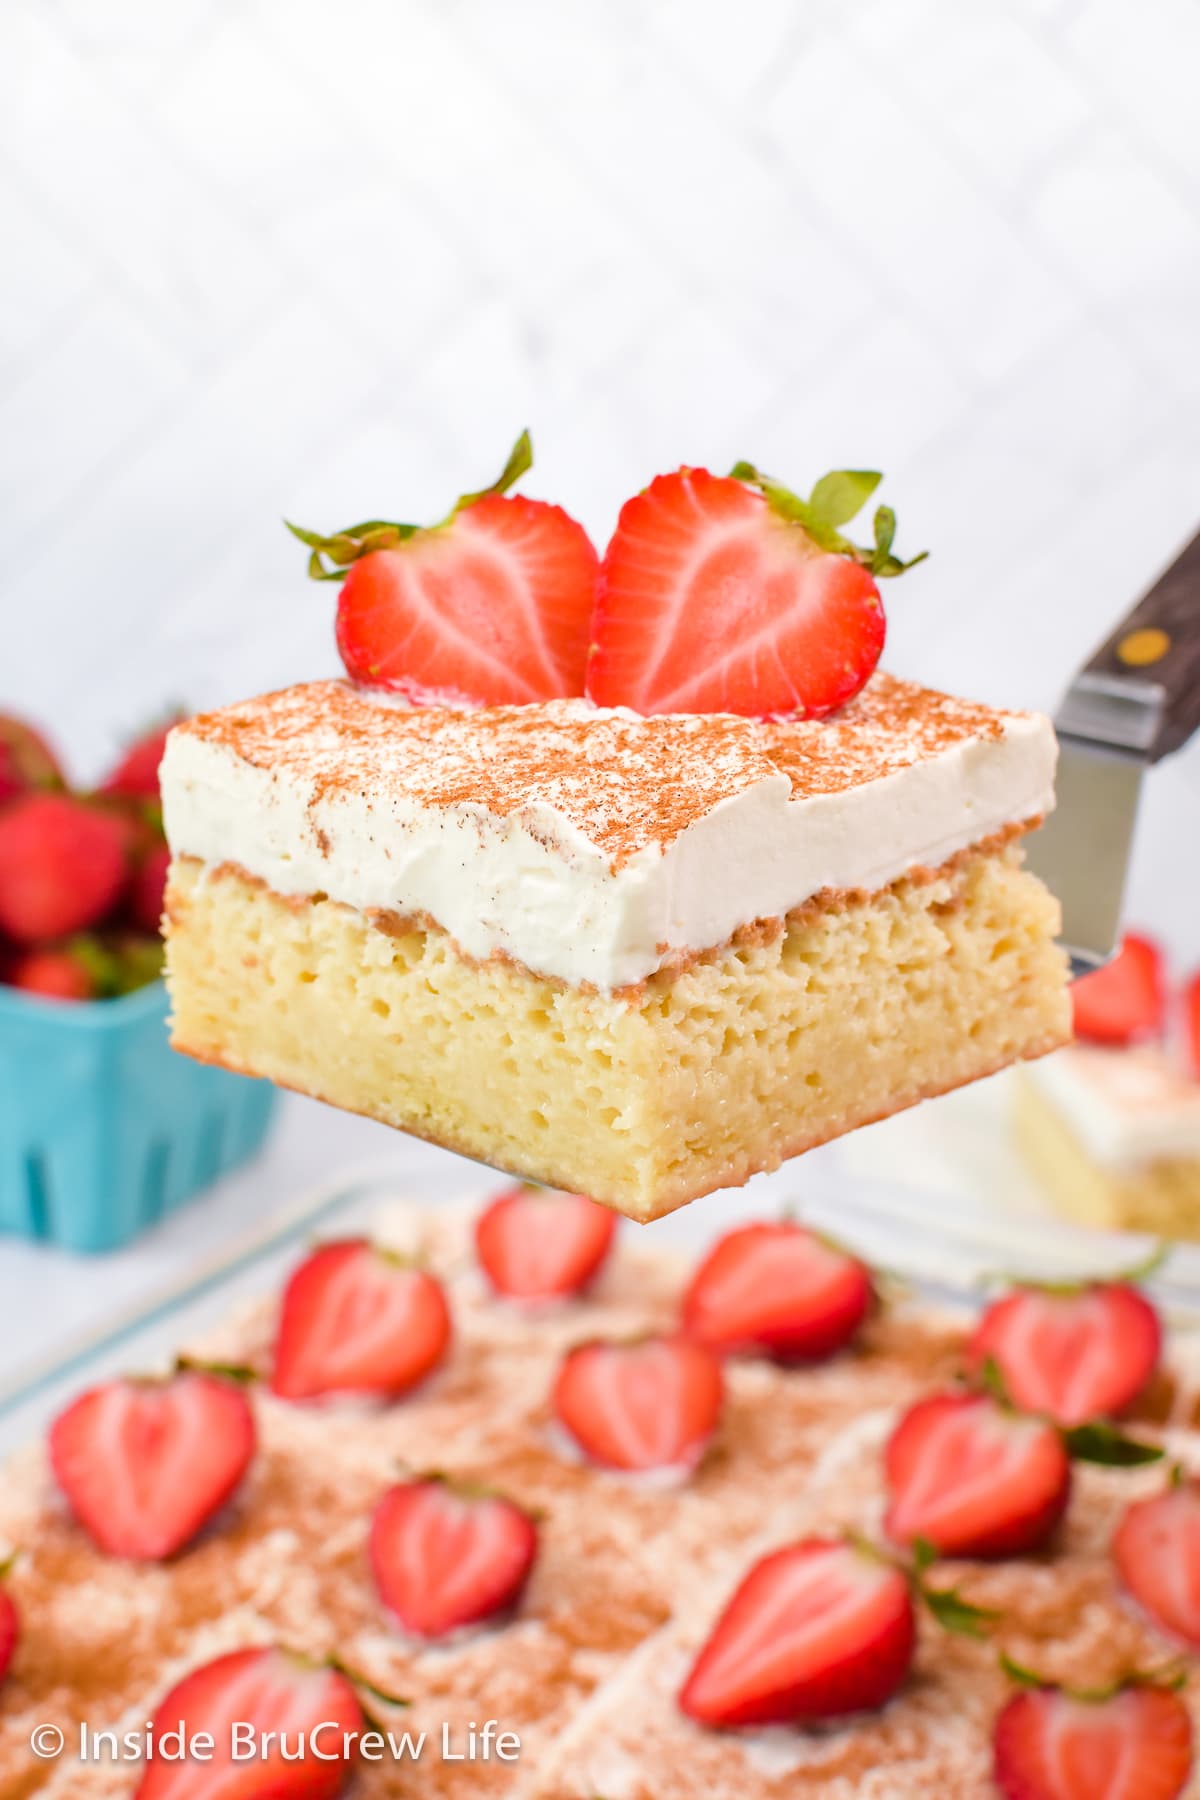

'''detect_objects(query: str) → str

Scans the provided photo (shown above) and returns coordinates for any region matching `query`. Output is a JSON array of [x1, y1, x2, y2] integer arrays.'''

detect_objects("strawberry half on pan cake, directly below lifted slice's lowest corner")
[[554, 1337, 723, 1471]]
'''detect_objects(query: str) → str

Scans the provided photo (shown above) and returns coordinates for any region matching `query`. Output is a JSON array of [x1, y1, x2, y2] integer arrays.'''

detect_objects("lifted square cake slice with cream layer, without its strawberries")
[[162, 675, 1069, 1219]]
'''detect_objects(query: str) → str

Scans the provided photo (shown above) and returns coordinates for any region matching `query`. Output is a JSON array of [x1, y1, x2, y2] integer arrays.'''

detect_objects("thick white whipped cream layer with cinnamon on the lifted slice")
[[162, 673, 1056, 990]]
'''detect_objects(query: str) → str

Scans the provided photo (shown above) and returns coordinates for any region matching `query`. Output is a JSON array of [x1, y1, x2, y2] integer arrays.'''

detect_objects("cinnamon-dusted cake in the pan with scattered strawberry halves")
[[0, 1190, 1200, 1800]]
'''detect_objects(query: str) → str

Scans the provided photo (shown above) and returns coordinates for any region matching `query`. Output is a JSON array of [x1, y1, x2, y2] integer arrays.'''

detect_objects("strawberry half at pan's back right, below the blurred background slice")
[[968, 1282, 1162, 1427]]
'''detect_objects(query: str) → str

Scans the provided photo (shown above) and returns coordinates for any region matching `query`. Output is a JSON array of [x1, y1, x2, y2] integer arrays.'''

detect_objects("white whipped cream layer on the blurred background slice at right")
[[1024, 1044, 1200, 1170]]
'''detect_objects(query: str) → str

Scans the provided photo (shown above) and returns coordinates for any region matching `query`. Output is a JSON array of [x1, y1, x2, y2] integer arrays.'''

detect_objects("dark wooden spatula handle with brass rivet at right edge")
[[1083, 535, 1200, 763]]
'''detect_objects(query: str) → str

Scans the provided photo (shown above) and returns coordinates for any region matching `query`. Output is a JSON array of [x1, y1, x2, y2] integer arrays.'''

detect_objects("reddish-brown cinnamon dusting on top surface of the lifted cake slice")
[[176, 671, 1018, 868]]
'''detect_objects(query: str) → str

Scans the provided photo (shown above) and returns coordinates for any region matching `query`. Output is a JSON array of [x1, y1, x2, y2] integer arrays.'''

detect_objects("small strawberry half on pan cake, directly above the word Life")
[[371, 1476, 538, 1638]]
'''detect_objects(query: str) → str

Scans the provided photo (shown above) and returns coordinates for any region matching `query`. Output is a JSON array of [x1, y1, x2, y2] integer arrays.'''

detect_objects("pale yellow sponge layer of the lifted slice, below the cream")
[[167, 846, 1070, 1219]]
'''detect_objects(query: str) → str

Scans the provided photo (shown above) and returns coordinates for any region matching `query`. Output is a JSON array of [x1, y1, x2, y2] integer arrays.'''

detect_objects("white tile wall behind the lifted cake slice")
[[0, 0, 1200, 961]]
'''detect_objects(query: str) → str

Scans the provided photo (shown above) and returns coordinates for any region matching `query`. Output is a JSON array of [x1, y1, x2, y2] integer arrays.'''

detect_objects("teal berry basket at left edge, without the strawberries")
[[0, 981, 275, 1251]]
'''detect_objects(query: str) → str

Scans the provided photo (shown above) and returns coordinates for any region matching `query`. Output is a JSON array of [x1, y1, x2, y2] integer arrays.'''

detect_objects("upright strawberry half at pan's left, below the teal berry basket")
[[49, 1370, 255, 1562]]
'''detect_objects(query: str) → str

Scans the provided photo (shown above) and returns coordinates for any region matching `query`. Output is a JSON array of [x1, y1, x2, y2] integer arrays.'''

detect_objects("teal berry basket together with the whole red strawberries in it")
[[0, 715, 272, 1249]]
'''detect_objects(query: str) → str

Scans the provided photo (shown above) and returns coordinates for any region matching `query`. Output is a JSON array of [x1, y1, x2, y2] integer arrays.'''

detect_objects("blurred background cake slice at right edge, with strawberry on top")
[[1013, 934, 1200, 1238]]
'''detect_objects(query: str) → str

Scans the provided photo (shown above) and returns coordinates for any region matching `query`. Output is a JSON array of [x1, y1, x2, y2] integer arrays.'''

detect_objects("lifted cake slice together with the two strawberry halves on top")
[[162, 441, 1069, 1219]]
